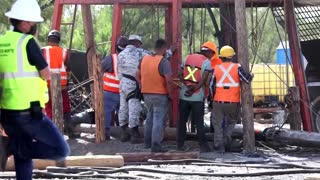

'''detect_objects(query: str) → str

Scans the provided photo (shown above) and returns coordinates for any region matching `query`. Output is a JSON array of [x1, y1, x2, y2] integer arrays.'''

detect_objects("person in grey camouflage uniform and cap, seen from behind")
[[118, 35, 176, 144]]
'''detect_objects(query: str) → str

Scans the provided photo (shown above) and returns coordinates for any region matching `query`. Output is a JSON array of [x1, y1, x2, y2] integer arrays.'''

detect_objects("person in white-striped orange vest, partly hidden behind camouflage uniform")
[[102, 36, 128, 140]]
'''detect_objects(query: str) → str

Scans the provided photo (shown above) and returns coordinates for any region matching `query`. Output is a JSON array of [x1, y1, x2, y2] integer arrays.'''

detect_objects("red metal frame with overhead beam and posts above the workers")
[[52, 0, 311, 131]]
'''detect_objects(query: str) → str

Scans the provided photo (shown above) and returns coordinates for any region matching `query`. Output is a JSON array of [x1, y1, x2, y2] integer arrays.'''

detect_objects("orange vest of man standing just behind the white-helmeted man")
[[42, 46, 68, 86]]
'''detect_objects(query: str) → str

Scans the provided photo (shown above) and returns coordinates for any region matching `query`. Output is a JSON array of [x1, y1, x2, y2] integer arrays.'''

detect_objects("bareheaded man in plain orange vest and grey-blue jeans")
[[136, 39, 172, 152]]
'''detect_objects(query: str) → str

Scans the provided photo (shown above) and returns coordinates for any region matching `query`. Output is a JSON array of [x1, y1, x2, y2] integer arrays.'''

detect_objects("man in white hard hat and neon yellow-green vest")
[[0, 0, 70, 180]]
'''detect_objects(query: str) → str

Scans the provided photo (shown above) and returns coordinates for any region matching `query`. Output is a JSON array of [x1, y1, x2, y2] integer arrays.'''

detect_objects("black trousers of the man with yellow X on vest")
[[177, 99, 207, 147]]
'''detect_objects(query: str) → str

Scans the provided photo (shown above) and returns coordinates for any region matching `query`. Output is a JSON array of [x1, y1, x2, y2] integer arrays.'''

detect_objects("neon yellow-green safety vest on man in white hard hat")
[[0, 31, 48, 110]]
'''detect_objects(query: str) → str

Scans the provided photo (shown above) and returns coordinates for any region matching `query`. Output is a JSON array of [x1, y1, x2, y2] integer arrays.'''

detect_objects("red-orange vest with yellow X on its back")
[[183, 54, 208, 93]]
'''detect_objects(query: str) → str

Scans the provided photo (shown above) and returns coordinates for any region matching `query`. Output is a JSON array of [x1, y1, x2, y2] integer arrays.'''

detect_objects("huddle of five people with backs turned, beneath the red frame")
[[102, 35, 252, 152]]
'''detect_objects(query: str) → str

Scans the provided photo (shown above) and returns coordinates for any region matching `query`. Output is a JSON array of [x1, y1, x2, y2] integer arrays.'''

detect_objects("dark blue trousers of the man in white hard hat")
[[1, 110, 70, 180]]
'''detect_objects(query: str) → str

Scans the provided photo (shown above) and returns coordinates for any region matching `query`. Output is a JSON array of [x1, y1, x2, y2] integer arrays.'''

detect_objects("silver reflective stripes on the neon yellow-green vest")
[[0, 34, 39, 79]]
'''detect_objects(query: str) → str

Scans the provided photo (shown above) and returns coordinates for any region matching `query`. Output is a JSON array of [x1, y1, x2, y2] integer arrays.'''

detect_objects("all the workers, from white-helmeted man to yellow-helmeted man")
[[0, 0, 252, 180]]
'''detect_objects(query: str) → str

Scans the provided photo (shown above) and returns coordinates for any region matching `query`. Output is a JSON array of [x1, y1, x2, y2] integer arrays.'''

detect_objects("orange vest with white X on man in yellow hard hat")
[[213, 62, 240, 103]]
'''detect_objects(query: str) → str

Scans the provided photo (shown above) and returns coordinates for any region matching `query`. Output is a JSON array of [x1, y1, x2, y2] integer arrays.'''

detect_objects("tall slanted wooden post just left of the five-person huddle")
[[81, 5, 105, 143]]
